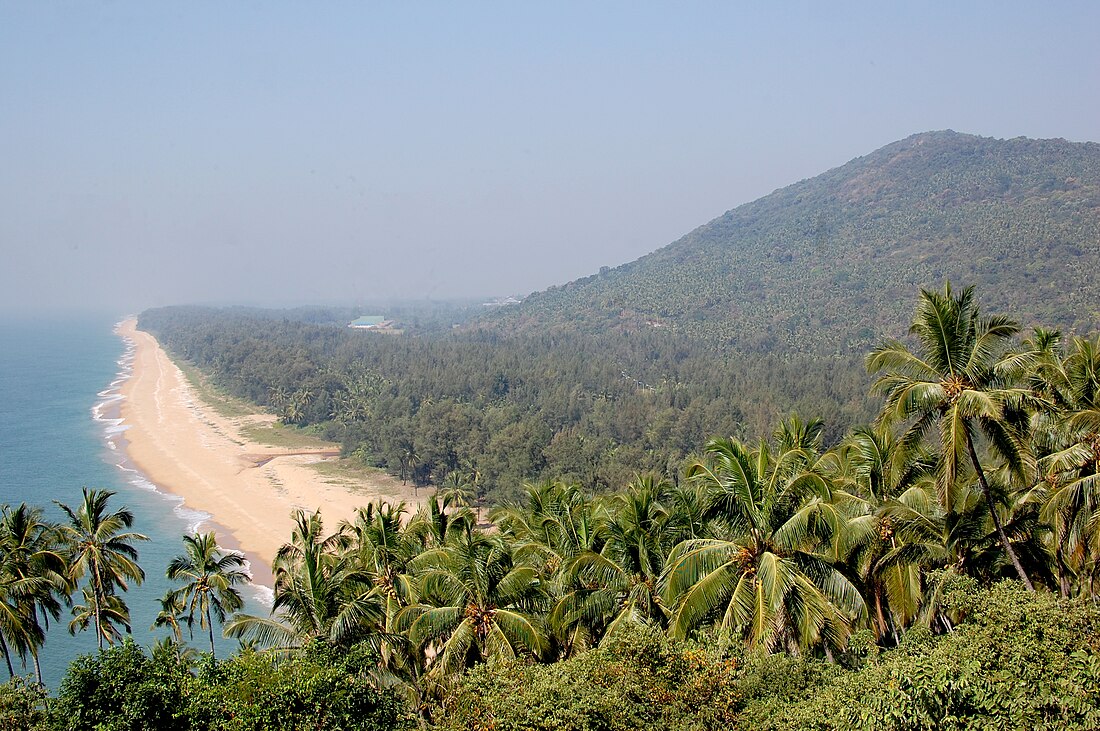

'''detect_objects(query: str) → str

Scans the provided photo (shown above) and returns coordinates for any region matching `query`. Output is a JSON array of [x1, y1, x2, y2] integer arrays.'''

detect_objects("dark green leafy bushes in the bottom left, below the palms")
[[46, 640, 411, 731]]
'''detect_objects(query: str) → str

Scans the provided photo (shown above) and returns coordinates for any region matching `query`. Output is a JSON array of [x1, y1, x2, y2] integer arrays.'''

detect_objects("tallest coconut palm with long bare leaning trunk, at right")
[[867, 284, 1035, 591]]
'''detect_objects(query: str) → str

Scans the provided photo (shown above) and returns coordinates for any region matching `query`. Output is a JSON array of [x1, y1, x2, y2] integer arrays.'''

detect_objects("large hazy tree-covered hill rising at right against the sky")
[[490, 131, 1100, 354]]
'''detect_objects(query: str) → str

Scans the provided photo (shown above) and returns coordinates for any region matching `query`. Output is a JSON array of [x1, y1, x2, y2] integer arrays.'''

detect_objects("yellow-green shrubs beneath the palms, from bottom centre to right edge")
[[439, 582, 1100, 731]]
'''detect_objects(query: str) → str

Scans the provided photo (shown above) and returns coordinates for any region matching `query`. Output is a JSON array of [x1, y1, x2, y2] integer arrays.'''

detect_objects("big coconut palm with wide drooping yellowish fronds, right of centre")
[[663, 422, 865, 652]]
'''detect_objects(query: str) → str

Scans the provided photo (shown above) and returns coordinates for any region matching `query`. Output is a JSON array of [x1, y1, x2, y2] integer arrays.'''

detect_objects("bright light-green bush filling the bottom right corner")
[[738, 583, 1100, 731]]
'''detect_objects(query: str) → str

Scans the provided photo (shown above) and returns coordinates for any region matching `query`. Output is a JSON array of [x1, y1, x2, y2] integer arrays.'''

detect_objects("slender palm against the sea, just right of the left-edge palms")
[[55, 487, 149, 650]]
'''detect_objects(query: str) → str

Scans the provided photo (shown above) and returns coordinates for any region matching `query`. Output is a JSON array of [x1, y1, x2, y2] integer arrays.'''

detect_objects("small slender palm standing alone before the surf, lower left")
[[165, 532, 252, 656]]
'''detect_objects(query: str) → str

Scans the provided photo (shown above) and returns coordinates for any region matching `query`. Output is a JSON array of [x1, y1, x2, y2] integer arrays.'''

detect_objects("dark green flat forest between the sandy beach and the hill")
[[139, 308, 872, 502]]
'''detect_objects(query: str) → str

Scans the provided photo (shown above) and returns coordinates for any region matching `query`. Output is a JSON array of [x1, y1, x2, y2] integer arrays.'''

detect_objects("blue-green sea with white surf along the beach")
[[0, 314, 270, 690]]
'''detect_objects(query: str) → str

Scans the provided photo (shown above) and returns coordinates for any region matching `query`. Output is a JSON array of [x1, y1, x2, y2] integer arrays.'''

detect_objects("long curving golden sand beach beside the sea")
[[118, 320, 428, 586]]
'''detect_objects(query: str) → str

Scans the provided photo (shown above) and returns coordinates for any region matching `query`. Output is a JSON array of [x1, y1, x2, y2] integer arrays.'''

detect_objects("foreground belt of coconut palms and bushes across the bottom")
[[0, 287, 1100, 731]]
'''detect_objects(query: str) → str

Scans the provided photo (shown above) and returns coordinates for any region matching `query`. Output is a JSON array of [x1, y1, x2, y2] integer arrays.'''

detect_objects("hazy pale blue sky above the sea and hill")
[[0, 0, 1100, 313]]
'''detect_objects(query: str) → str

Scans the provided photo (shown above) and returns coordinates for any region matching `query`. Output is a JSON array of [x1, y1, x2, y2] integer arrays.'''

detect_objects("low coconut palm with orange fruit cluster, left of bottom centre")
[[398, 532, 548, 676]]
